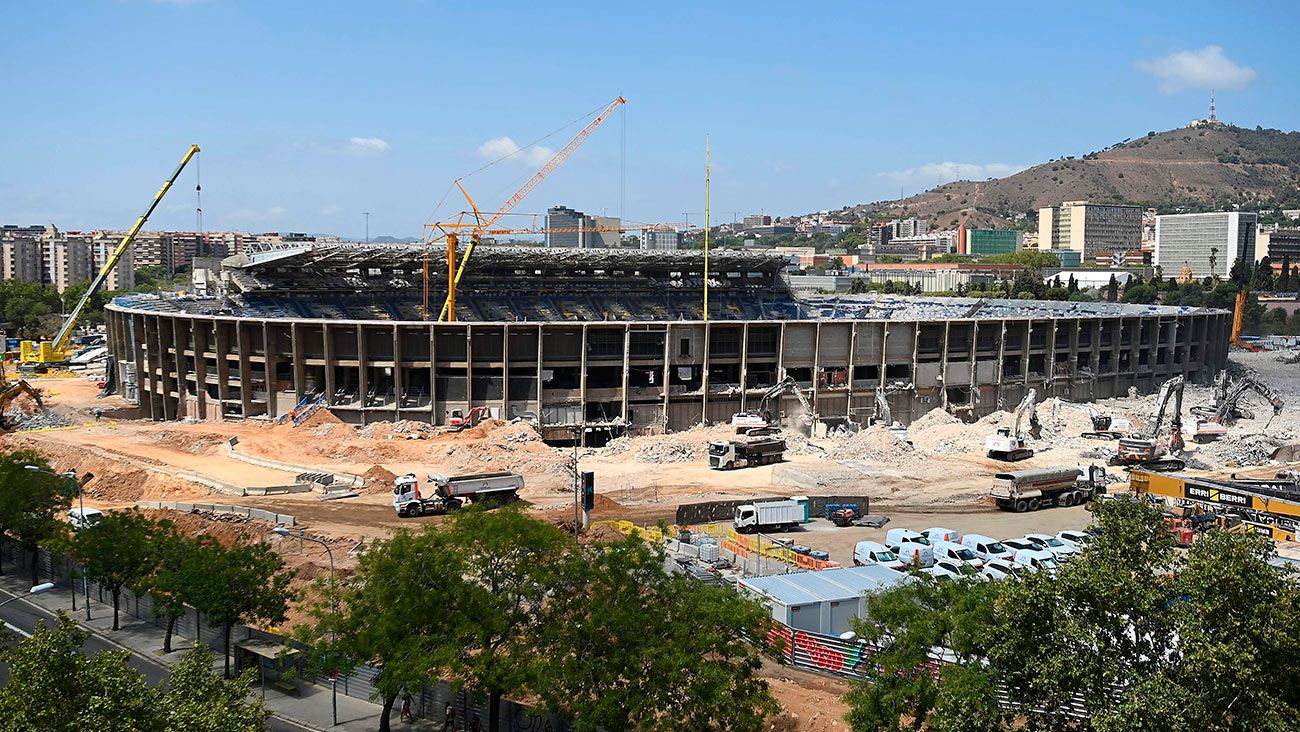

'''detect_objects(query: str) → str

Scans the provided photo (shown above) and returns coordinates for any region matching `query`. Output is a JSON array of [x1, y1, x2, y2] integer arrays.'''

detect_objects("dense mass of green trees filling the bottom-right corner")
[[846, 501, 1300, 732]]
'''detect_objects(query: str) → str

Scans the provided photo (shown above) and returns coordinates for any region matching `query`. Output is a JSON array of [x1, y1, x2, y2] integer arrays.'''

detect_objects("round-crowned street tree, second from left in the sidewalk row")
[[72, 508, 170, 631]]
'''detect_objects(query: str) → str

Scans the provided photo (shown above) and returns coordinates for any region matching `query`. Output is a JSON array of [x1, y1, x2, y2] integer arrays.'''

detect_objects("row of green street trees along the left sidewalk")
[[0, 450, 293, 676]]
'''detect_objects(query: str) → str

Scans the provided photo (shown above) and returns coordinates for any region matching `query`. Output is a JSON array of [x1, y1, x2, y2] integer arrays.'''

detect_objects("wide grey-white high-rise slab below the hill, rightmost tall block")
[[1154, 211, 1258, 277]]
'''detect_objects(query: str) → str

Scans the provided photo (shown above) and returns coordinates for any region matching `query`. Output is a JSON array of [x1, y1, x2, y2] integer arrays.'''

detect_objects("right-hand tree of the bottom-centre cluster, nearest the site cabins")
[[534, 538, 776, 732]]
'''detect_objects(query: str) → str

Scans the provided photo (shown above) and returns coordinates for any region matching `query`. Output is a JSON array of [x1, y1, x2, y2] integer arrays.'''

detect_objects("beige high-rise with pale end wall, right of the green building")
[[1039, 200, 1141, 261]]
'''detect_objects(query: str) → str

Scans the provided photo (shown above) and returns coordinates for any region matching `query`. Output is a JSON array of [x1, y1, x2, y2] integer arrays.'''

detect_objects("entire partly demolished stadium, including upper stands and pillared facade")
[[107, 246, 1231, 443]]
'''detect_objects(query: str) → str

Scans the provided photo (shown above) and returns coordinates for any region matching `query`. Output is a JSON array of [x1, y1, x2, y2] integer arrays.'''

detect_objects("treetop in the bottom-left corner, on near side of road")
[[0, 611, 162, 732]]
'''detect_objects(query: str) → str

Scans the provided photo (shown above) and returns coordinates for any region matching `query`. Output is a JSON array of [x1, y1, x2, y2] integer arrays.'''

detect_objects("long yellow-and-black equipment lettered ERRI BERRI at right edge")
[[1128, 468, 1300, 541]]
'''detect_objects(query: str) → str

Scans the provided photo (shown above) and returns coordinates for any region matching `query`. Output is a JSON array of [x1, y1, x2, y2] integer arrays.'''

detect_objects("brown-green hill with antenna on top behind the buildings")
[[850, 124, 1300, 229]]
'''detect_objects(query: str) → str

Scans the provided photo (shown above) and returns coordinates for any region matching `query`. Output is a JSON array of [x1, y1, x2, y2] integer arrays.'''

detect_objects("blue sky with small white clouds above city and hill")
[[0, 0, 1300, 237]]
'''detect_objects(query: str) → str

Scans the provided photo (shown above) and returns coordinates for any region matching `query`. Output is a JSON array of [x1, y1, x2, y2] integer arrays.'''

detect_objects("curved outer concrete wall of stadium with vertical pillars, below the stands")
[[107, 304, 1231, 439]]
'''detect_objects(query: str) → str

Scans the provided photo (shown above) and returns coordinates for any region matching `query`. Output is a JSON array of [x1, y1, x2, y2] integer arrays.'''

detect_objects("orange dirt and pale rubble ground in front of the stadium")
[[0, 352, 1300, 729]]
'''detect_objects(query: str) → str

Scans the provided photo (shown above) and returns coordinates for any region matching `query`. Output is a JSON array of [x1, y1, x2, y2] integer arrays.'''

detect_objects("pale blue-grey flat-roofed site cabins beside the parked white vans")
[[737, 564, 910, 636]]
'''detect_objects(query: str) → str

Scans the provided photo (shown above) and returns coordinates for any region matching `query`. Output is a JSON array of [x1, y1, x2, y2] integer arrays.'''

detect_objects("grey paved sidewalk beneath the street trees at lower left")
[[0, 579, 434, 732]]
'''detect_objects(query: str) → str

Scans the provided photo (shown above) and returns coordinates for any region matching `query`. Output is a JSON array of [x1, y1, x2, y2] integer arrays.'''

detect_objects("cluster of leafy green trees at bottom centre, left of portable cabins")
[[302, 507, 777, 732]]
